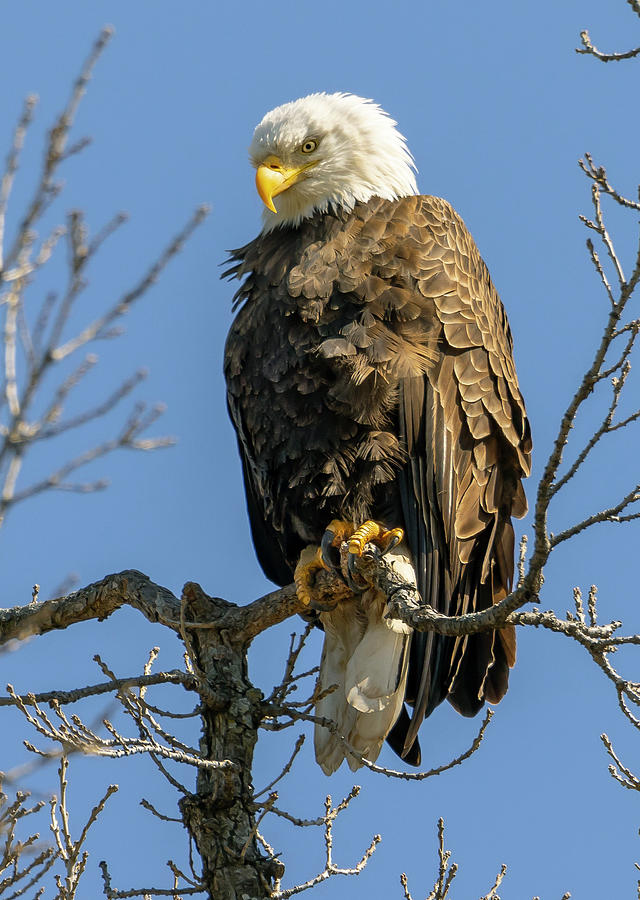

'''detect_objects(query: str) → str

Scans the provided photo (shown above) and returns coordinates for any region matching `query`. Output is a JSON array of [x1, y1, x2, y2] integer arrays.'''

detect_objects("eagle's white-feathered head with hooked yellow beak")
[[249, 94, 418, 231]]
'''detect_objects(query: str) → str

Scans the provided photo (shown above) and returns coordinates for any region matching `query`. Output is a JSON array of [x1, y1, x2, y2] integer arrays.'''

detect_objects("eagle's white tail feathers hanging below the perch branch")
[[314, 553, 415, 775]]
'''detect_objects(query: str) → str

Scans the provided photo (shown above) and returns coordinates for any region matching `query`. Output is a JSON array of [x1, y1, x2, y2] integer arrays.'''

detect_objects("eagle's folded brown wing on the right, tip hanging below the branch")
[[399, 198, 531, 749]]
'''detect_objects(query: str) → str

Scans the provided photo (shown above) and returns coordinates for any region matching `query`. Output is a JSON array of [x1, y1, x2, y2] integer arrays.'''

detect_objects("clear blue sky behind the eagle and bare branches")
[[0, 0, 640, 900]]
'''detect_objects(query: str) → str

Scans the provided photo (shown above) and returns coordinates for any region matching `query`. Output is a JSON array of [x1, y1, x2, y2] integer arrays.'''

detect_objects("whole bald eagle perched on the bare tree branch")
[[225, 93, 531, 773]]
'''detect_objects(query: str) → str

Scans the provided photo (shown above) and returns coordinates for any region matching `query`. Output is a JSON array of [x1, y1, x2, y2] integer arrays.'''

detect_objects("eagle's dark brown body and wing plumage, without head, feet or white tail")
[[225, 196, 531, 752]]
